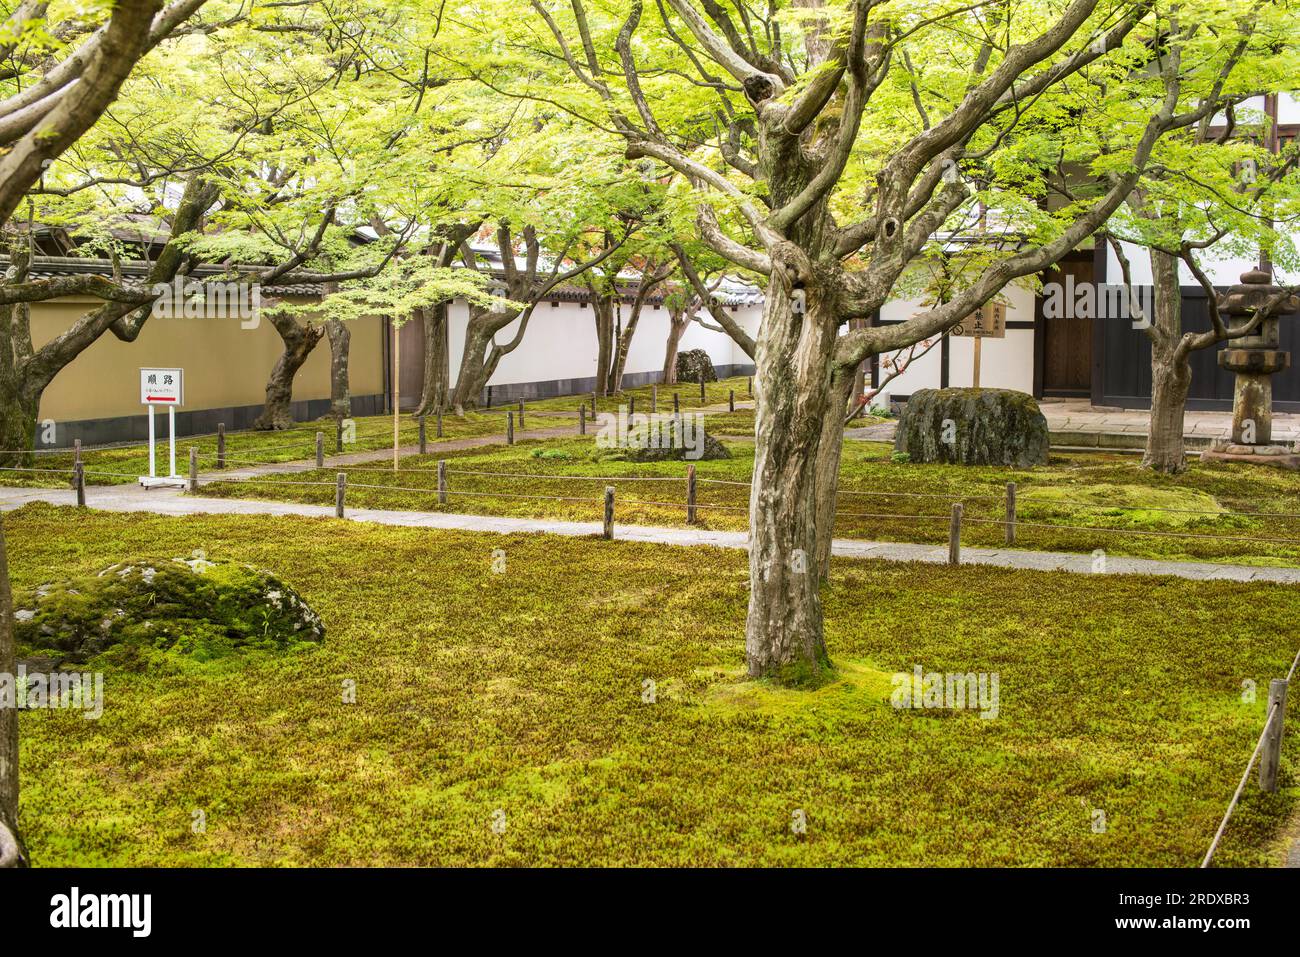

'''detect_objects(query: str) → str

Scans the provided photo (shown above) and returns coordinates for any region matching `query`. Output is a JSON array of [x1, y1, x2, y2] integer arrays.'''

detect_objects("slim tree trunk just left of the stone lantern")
[[1141, 250, 1192, 475]]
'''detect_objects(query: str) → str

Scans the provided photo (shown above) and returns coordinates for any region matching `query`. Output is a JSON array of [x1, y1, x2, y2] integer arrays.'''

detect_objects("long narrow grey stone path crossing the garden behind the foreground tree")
[[0, 485, 1300, 584]]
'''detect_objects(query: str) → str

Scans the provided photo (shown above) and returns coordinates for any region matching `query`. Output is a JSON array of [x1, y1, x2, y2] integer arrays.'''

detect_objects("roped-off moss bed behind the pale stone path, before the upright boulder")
[[203, 434, 1300, 566]]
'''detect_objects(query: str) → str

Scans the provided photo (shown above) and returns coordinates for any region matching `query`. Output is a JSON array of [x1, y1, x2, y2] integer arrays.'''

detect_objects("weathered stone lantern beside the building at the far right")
[[1206, 269, 1300, 468]]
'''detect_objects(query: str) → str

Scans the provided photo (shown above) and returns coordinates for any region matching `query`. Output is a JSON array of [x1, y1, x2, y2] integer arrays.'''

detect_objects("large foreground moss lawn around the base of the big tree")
[[5, 506, 1300, 867]]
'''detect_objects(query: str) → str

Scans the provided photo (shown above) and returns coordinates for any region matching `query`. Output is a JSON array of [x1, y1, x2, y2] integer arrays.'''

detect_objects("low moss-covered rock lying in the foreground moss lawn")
[[14, 558, 325, 663]]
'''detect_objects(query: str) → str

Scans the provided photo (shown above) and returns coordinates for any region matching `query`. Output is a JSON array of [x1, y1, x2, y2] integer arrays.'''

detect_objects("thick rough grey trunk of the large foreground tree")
[[745, 274, 842, 683]]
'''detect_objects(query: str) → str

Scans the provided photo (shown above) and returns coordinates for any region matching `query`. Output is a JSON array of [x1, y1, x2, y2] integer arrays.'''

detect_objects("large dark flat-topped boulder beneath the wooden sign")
[[894, 389, 1050, 468]]
